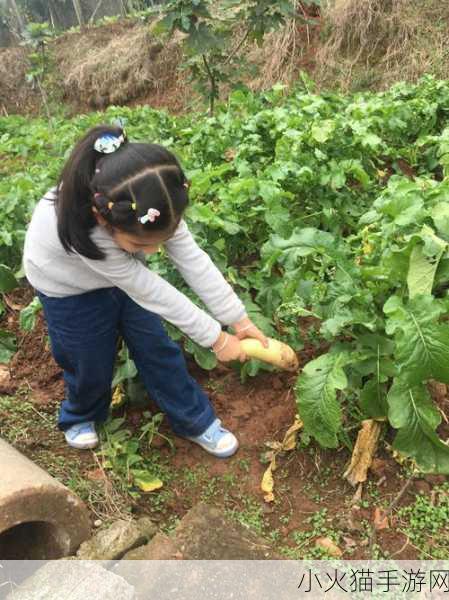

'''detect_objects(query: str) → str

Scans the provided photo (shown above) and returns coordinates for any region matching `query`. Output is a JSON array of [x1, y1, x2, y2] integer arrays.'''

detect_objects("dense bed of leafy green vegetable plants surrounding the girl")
[[0, 76, 449, 556]]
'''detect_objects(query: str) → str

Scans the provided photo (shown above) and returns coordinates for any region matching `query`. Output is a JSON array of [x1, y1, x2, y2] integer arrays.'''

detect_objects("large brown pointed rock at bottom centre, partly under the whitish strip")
[[113, 503, 284, 600]]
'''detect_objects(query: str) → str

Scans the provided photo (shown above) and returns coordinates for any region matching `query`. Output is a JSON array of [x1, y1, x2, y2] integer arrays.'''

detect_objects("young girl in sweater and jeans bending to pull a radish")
[[24, 126, 267, 457]]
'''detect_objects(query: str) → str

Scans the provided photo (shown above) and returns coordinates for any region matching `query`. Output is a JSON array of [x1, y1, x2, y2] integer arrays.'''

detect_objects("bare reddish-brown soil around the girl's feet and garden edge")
[[0, 288, 448, 559]]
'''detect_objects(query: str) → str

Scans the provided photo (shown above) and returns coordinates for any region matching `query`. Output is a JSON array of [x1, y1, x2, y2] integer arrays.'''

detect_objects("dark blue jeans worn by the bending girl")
[[37, 288, 215, 436]]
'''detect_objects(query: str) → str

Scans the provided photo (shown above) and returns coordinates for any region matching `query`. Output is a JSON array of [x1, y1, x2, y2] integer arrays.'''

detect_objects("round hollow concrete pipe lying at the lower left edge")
[[0, 439, 90, 560]]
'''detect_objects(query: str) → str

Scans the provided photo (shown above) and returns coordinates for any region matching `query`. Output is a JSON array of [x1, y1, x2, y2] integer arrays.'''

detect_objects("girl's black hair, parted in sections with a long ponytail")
[[56, 125, 188, 259]]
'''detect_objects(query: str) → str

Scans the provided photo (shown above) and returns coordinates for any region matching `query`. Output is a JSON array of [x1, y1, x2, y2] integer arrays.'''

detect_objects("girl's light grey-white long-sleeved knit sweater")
[[23, 188, 246, 347]]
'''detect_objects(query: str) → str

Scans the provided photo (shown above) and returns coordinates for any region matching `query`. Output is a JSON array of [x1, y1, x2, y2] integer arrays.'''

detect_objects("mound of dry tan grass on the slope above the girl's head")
[[53, 21, 184, 109]]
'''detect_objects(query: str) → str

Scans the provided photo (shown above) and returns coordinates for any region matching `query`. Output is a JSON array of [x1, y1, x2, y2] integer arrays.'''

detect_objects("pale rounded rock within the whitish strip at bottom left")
[[6, 560, 136, 600]]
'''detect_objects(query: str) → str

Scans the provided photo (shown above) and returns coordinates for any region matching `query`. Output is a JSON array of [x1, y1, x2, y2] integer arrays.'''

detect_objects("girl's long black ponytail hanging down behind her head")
[[56, 125, 123, 259]]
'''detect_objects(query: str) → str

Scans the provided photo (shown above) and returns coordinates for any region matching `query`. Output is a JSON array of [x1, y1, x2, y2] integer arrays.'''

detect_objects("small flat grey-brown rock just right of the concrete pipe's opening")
[[76, 517, 157, 560]]
